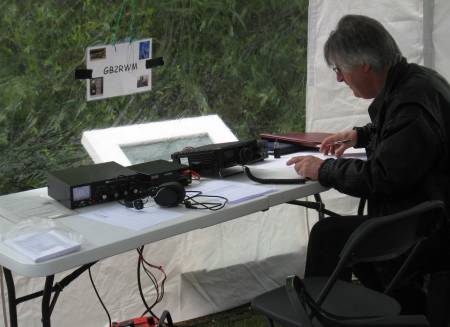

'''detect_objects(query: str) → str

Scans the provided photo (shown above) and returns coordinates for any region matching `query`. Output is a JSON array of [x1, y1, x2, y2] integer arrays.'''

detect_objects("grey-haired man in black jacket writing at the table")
[[287, 15, 450, 318]]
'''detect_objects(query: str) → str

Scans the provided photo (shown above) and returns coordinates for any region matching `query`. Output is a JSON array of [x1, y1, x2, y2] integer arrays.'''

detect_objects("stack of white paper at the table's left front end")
[[4, 230, 81, 262]]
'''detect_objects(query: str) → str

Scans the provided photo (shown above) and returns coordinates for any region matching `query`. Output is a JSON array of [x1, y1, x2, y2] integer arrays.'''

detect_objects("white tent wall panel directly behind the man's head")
[[306, 0, 431, 132]]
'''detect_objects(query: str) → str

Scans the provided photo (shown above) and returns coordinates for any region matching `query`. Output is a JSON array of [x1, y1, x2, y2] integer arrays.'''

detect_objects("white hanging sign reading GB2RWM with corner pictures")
[[86, 39, 152, 101]]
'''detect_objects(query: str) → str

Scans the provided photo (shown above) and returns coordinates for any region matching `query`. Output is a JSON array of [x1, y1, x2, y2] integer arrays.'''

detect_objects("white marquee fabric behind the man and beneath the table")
[[0, 0, 450, 327]]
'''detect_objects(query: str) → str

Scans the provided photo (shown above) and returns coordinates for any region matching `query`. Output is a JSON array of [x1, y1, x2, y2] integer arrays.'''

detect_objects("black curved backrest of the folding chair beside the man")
[[317, 201, 446, 305]]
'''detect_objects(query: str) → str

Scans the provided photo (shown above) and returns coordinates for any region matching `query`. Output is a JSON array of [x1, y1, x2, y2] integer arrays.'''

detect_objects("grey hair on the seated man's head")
[[324, 15, 402, 72]]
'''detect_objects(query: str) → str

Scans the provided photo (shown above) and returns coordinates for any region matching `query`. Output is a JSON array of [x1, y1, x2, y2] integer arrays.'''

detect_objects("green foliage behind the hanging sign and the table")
[[0, 0, 307, 194]]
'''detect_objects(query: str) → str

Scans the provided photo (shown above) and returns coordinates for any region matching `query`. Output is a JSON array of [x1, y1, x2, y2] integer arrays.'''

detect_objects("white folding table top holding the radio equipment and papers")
[[0, 159, 327, 277]]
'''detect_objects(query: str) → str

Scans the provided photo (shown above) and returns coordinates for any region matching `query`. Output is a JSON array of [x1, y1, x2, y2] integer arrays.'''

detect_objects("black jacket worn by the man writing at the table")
[[319, 59, 450, 216]]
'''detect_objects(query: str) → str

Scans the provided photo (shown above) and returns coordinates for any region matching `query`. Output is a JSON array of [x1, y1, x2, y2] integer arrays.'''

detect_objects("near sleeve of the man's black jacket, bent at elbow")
[[319, 104, 443, 198]]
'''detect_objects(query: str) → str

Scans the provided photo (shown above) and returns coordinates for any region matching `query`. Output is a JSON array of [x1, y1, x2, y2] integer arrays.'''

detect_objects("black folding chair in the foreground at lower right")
[[252, 201, 446, 327]]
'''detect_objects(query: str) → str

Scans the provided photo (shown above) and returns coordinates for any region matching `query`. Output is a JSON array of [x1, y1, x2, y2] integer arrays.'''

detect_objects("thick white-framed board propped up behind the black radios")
[[80, 115, 238, 167]]
